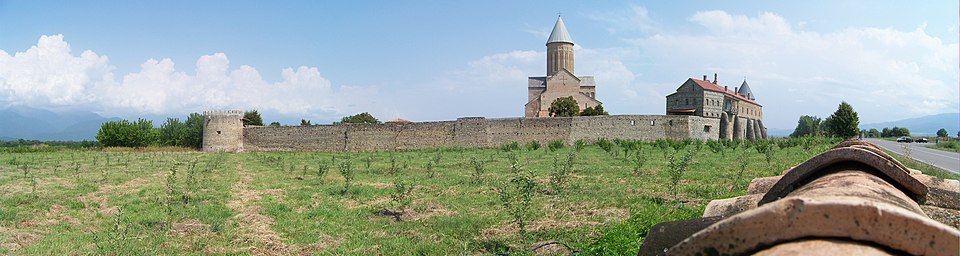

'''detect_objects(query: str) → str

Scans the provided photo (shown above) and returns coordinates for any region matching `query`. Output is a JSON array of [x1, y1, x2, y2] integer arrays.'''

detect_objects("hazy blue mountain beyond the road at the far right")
[[860, 113, 960, 136]]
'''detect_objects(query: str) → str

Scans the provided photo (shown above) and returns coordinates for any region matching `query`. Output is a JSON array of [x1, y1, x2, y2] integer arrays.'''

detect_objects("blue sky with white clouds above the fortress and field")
[[0, 0, 960, 128]]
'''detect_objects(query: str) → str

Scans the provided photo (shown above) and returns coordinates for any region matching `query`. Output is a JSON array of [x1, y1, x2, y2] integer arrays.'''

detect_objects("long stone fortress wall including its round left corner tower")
[[203, 113, 720, 152]]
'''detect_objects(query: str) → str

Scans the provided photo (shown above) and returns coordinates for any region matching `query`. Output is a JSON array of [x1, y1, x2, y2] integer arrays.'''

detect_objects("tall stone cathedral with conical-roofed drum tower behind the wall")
[[524, 17, 602, 117]]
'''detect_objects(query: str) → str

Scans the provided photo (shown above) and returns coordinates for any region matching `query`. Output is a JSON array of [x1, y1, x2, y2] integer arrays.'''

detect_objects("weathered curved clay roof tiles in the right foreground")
[[640, 140, 960, 255]]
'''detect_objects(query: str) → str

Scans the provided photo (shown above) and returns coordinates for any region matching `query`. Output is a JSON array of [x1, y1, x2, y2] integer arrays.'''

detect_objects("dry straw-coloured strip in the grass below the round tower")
[[227, 165, 343, 255]]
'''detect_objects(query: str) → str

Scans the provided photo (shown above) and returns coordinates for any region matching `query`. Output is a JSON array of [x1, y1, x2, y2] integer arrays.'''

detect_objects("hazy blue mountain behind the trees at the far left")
[[0, 107, 120, 141]]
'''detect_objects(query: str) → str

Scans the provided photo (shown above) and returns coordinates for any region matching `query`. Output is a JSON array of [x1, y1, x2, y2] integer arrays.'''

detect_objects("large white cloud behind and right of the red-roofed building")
[[632, 11, 960, 128]]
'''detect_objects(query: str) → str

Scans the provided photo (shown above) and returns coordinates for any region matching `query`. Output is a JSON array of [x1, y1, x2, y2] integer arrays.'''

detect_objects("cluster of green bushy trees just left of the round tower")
[[97, 113, 203, 148]]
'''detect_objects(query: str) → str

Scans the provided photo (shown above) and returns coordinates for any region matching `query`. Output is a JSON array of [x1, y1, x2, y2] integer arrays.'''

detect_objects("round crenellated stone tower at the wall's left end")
[[203, 110, 243, 152]]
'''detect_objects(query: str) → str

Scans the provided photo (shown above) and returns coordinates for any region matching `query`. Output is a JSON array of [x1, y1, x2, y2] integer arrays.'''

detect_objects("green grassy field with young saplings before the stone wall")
[[0, 139, 956, 255]]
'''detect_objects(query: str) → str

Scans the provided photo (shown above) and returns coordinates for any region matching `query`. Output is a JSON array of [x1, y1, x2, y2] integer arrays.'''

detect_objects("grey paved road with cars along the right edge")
[[865, 139, 960, 173]]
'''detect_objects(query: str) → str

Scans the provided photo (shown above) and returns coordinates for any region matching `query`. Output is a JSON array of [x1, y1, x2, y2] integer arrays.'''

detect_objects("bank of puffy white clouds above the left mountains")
[[0, 35, 377, 119]]
